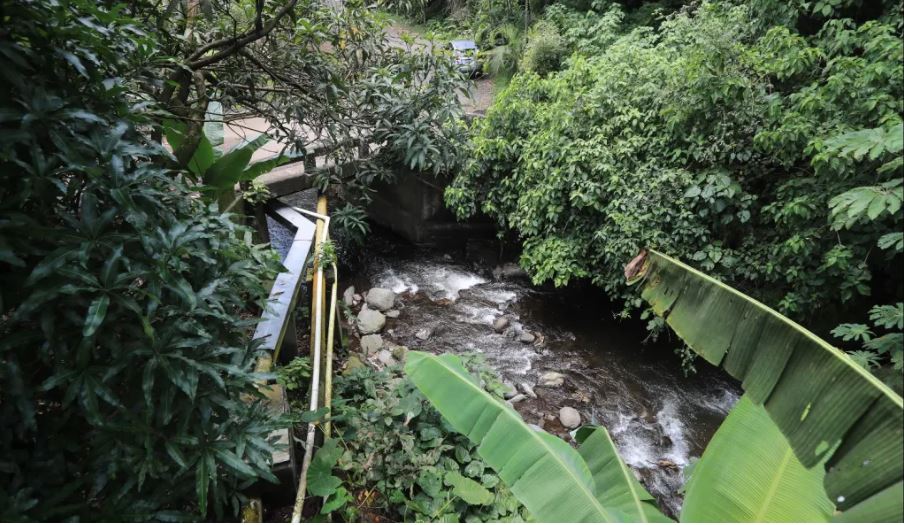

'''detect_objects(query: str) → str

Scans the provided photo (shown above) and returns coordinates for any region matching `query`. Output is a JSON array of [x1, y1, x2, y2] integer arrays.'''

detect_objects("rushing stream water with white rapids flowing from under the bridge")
[[264, 206, 740, 515]]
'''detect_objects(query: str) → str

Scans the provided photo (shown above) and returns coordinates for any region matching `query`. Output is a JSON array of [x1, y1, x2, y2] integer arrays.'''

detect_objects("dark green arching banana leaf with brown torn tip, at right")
[[625, 250, 904, 521]]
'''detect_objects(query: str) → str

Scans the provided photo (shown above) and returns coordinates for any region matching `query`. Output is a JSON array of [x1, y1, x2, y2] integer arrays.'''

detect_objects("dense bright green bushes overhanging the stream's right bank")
[[446, 1, 904, 372]]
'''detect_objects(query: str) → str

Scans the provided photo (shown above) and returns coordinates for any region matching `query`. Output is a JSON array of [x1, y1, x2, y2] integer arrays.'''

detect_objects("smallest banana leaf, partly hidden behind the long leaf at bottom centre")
[[575, 426, 672, 523]]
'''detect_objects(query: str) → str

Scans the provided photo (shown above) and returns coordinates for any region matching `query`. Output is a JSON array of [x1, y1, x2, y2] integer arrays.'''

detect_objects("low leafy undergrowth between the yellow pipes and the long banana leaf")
[[324, 358, 525, 522]]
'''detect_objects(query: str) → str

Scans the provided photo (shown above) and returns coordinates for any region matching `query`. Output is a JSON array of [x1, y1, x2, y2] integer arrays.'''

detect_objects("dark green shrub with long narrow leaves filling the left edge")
[[0, 0, 278, 521]]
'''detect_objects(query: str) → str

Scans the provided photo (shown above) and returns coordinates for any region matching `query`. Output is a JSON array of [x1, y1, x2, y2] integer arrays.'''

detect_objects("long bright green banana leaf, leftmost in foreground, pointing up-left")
[[405, 352, 621, 522]]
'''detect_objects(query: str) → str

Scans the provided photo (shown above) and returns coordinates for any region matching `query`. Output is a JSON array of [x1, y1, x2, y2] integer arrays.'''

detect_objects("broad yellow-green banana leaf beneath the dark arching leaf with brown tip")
[[681, 396, 834, 522]]
